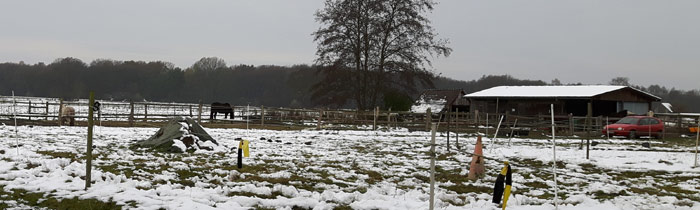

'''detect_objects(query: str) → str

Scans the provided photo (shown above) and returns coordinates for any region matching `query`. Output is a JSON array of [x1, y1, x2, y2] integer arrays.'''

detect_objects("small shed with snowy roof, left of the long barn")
[[411, 89, 469, 113]]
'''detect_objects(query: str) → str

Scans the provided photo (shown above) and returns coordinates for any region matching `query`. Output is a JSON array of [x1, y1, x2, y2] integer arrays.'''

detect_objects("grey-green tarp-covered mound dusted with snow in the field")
[[136, 117, 219, 147]]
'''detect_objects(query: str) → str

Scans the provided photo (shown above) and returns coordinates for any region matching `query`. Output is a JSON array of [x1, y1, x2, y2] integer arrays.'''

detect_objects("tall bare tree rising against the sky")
[[313, 0, 452, 110]]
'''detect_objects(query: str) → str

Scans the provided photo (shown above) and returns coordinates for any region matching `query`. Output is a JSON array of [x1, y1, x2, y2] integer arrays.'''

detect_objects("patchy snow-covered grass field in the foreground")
[[0, 125, 700, 210]]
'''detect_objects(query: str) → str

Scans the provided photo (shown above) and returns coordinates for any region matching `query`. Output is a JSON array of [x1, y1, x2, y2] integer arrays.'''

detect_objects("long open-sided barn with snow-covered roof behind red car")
[[464, 85, 661, 116]]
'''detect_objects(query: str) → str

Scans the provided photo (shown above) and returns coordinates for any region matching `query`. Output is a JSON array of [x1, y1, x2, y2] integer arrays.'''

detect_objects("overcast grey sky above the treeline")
[[0, 0, 700, 89]]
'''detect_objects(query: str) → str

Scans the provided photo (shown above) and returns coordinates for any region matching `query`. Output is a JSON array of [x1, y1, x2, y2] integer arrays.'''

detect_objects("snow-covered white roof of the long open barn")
[[464, 85, 661, 100]]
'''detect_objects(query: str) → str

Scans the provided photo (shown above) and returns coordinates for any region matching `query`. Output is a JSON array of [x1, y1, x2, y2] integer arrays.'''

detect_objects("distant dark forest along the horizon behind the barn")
[[0, 57, 700, 112]]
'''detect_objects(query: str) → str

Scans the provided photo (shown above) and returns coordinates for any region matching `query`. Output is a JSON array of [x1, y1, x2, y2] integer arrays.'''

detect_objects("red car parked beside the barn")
[[603, 116, 664, 139]]
